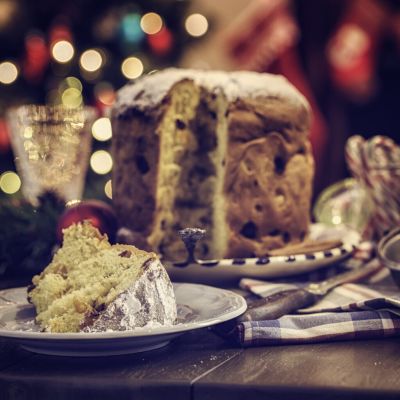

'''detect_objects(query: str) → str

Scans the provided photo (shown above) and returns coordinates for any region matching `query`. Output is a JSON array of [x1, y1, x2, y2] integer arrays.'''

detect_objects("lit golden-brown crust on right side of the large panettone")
[[225, 99, 314, 257]]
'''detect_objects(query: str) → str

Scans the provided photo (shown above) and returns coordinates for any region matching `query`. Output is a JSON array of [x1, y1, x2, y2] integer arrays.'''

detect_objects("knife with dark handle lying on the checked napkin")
[[235, 258, 384, 323]]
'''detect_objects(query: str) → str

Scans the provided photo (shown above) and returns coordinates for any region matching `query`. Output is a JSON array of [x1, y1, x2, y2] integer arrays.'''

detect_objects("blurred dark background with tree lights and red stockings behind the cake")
[[0, 0, 400, 202]]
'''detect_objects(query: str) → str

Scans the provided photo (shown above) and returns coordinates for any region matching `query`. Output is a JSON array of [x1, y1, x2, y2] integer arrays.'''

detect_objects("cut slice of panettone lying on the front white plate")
[[28, 222, 176, 332]]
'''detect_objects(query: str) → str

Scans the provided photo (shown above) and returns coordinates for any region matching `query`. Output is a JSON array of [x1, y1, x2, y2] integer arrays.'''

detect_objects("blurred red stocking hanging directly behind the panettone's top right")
[[226, 0, 328, 192]]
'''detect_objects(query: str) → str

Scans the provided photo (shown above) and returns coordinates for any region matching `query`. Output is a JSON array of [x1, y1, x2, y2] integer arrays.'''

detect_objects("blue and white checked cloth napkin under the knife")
[[219, 247, 400, 347]]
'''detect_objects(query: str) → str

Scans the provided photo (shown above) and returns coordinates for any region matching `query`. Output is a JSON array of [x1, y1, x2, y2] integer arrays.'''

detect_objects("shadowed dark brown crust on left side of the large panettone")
[[112, 108, 159, 238]]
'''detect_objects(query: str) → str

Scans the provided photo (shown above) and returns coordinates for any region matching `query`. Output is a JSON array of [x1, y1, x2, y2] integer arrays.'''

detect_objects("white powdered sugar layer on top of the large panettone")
[[115, 68, 308, 114]]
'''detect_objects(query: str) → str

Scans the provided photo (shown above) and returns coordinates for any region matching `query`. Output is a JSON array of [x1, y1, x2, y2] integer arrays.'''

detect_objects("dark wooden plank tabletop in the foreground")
[[0, 278, 400, 400]]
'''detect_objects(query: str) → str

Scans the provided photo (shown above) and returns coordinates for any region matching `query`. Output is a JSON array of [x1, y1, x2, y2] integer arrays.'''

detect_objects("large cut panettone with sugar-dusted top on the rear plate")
[[112, 69, 314, 259]]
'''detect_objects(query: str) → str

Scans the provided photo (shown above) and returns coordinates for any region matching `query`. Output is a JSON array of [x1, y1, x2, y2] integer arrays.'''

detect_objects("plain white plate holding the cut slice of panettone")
[[0, 283, 247, 357]]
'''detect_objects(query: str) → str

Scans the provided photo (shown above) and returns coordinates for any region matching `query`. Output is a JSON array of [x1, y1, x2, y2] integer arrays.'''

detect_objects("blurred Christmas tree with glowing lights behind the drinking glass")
[[0, 0, 208, 201]]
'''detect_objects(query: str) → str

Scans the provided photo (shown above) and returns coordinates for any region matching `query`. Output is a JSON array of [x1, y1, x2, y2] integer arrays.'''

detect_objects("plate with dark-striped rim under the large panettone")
[[163, 224, 360, 284]]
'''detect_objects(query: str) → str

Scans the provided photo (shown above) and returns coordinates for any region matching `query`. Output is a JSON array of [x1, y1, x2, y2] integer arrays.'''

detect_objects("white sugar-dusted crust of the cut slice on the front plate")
[[83, 260, 177, 332]]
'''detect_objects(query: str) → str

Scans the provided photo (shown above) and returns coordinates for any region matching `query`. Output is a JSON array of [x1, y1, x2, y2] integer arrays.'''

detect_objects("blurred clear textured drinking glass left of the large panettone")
[[7, 105, 96, 204]]
